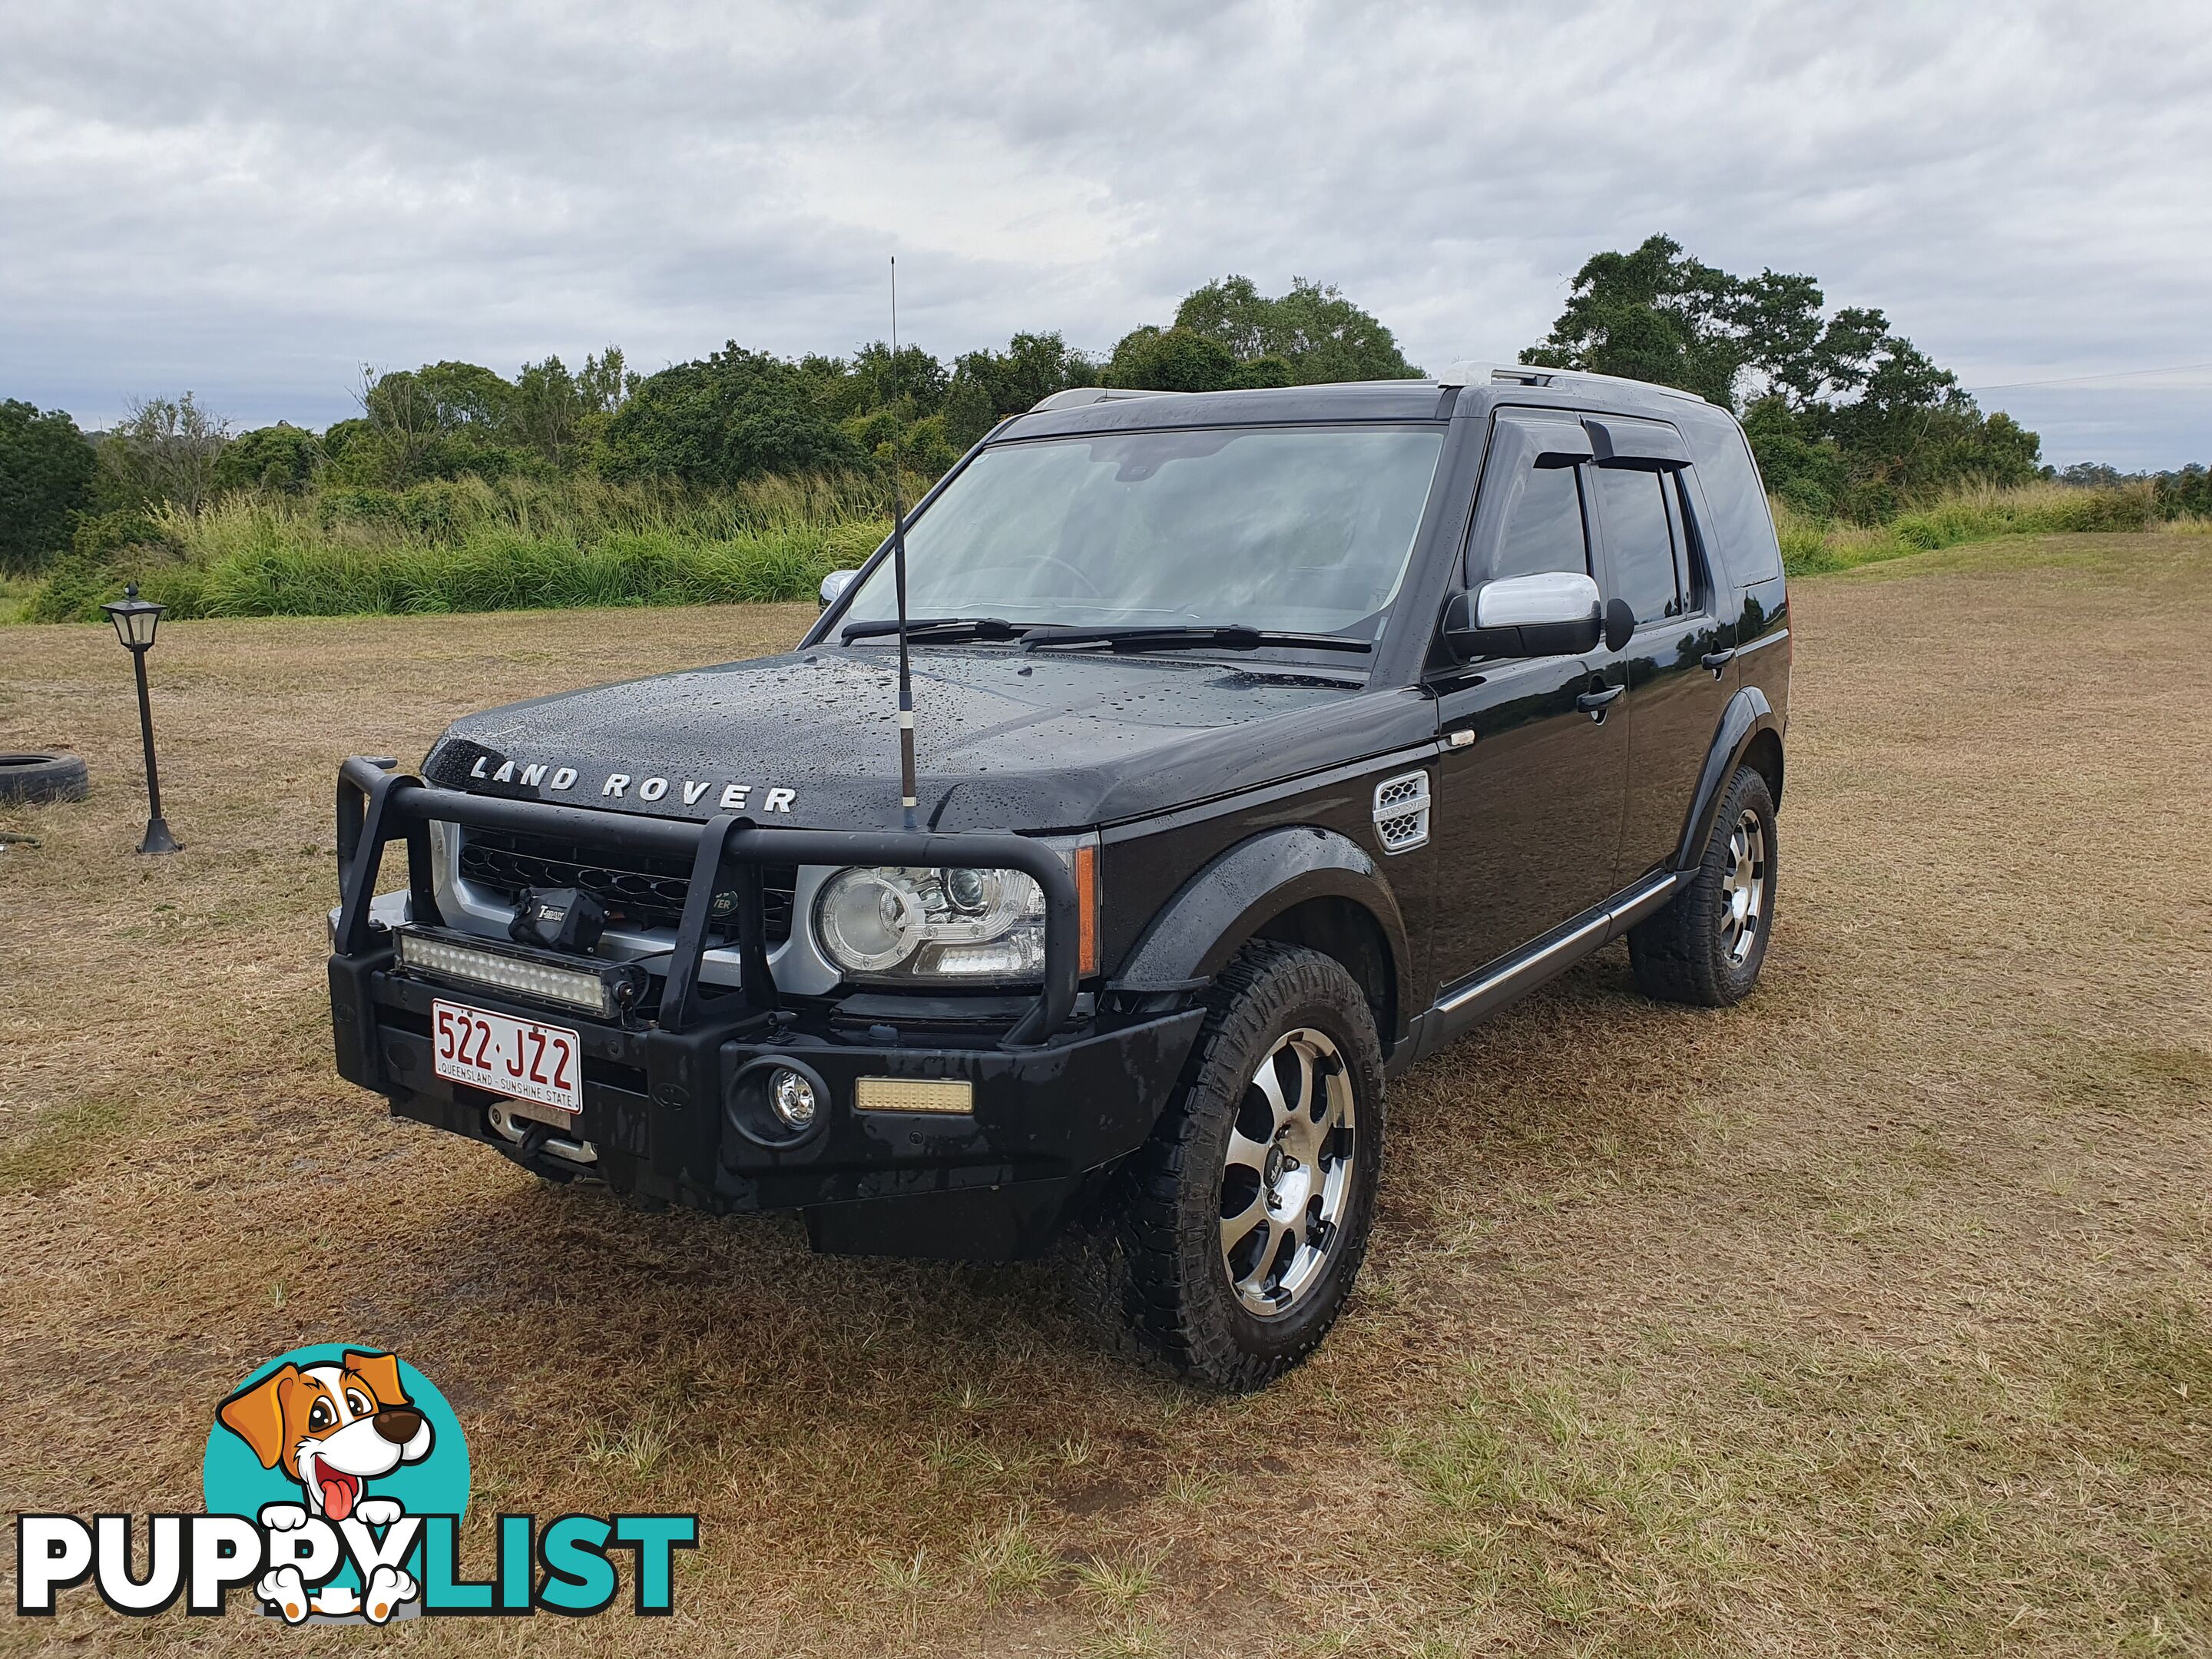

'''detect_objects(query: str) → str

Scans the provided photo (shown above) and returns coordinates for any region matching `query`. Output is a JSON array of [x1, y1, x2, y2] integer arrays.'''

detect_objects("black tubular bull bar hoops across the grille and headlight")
[[336, 754, 1079, 1048]]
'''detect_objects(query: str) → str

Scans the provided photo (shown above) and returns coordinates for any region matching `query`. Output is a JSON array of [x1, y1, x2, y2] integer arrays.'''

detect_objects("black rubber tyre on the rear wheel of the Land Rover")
[[1628, 765, 1774, 1008]]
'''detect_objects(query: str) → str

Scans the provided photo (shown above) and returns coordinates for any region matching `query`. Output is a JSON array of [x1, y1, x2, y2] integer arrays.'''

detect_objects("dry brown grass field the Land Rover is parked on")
[[0, 535, 2212, 1659]]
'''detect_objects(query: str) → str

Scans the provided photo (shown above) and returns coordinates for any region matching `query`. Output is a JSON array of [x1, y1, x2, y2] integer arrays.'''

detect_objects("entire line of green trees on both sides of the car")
[[0, 237, 2212, 571]]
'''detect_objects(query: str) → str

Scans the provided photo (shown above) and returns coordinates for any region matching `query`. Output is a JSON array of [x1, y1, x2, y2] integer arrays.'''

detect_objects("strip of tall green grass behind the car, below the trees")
[[12, 475, 2212, 624]]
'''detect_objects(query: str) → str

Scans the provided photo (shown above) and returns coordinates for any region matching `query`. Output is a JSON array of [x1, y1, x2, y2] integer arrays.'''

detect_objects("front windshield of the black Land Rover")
[[843, 425, 1445, 639]]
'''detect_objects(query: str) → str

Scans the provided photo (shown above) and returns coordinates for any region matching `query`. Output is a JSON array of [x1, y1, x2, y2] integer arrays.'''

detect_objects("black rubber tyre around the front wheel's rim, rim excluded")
[[1115, 940, 1385, 1392]]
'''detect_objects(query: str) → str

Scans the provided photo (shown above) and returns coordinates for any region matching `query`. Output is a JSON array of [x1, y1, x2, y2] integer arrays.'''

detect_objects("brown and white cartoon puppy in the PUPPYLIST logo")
[[214, 1349, 432, 1624]]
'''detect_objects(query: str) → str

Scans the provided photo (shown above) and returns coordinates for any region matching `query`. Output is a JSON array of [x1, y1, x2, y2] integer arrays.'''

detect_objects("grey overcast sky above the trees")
[[0, 0, 2212, 469]]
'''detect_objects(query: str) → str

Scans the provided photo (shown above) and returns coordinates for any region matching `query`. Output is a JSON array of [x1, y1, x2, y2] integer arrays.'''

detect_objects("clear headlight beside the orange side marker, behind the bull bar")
[[814, 867, 1044, 980]]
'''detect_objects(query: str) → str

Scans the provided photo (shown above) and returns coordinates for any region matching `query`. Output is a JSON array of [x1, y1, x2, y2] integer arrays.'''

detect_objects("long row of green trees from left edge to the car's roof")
[[0, 276, 1420, 571]]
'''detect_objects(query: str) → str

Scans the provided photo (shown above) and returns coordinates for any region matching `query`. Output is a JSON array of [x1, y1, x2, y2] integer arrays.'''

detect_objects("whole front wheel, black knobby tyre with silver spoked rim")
[[1121, 940, 1382, 1389]]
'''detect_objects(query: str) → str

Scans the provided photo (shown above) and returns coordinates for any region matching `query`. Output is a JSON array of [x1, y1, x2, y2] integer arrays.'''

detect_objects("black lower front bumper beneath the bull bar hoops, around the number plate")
[[329, 951, 1206, 1261]]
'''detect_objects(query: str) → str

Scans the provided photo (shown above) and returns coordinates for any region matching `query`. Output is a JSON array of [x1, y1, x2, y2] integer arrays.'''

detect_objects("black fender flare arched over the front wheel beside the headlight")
[[1111, 825, 1411, 1015]]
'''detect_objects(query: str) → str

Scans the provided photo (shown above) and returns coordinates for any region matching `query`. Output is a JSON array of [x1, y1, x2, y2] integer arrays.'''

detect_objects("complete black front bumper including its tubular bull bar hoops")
[[329, 763, 1204, 1259]]
